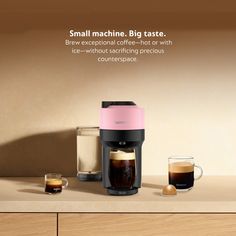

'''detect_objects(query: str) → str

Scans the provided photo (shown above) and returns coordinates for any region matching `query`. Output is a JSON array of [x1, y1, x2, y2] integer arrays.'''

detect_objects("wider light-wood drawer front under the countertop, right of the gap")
[[59, 213, 236, 236]]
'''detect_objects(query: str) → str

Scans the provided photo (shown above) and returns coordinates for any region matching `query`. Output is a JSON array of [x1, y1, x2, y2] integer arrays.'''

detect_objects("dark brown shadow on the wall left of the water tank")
[[0, 130, 77, 177]]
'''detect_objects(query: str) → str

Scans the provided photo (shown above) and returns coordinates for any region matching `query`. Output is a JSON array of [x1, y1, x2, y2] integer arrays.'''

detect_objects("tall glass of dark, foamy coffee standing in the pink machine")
[[109, 150, 135, 190]]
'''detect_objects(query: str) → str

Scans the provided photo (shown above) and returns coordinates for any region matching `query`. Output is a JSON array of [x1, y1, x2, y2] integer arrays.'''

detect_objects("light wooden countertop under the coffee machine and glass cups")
[[0, 176, 236, 213]]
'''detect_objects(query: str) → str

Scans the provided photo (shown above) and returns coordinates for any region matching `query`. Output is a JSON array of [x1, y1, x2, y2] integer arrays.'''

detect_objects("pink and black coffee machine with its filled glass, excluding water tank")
[[100, 101, 145, 195]]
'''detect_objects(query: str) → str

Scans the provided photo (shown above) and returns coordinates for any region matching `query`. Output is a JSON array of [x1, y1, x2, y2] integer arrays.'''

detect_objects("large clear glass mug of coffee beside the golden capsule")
[[168, 156, 203, 191]]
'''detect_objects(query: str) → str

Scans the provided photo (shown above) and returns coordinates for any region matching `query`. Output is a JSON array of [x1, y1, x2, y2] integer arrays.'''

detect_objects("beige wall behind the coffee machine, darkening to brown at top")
[[0, 1, 236, 175]]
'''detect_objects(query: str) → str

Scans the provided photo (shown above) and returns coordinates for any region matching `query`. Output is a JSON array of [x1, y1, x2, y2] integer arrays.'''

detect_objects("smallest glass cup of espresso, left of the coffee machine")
[[45, 173, 68, 194]]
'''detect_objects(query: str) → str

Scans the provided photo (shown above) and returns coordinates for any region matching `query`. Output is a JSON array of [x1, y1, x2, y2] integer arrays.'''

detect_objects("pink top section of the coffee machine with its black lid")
[[100, 101, 144, 130]]
